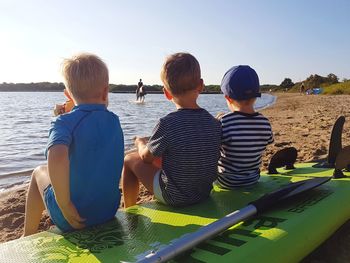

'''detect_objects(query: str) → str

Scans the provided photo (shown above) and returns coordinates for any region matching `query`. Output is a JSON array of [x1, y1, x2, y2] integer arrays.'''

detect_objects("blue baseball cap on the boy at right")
[[221, 65, 261, 100]]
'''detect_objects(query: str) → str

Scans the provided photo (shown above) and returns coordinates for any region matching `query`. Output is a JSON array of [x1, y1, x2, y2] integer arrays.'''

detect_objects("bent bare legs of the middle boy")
[[122, 152, 159, 208]]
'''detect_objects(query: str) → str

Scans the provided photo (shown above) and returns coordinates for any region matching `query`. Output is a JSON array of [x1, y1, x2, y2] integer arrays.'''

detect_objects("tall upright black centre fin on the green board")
[[315, 116, 345, 168]]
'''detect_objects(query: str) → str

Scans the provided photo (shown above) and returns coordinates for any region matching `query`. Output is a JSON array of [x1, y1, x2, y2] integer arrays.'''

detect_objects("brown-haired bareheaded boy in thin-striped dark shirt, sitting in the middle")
[[122, 53, 221, 207]]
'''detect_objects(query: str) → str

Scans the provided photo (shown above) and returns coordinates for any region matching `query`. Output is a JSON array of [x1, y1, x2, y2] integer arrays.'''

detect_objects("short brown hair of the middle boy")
[[160, 53, 201, 96]]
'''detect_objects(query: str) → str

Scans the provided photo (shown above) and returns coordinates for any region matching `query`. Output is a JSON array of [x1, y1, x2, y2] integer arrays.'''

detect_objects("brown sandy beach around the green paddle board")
[[0, 93, 350, 263]]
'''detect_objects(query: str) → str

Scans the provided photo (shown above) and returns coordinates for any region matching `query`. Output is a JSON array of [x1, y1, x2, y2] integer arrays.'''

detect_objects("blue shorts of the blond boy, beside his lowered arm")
[[44, 184, 74, 232]]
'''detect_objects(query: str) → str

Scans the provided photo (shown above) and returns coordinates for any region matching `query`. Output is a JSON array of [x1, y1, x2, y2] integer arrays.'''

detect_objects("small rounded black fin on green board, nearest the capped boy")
[[268, 147, 298, 174]]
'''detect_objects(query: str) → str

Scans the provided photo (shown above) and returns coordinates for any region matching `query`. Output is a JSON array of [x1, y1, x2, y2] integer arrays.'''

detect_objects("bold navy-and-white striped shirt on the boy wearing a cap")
[[218, 111, 273, 188]]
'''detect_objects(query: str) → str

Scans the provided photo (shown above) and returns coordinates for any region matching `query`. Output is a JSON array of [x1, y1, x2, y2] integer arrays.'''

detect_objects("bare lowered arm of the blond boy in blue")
[[48, 145, 84, 229]]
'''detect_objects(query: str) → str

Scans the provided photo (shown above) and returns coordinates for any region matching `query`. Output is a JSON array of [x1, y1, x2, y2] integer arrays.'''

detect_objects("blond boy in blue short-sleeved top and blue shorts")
[[24, 54, 124, 236]]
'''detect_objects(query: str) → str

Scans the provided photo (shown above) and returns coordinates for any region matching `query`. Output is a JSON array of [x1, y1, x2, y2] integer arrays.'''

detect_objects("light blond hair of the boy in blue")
[[62, 53, 109, 99]]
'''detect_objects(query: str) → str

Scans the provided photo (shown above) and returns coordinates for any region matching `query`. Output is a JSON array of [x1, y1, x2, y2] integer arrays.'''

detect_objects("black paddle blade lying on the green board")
[[251, 177, 332, 213]]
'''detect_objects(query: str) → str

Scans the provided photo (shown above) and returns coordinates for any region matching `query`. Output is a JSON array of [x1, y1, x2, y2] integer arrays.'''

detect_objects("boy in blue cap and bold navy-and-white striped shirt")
[[217, 65, 273, 189]]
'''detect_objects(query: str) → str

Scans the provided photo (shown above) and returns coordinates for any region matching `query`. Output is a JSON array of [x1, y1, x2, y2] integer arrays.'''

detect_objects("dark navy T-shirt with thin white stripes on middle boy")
[[147, 108, 221, 206]]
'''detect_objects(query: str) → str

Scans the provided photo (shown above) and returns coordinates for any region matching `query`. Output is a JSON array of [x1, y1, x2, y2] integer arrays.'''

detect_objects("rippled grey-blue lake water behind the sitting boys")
[[0, 92, 275, 190]]
